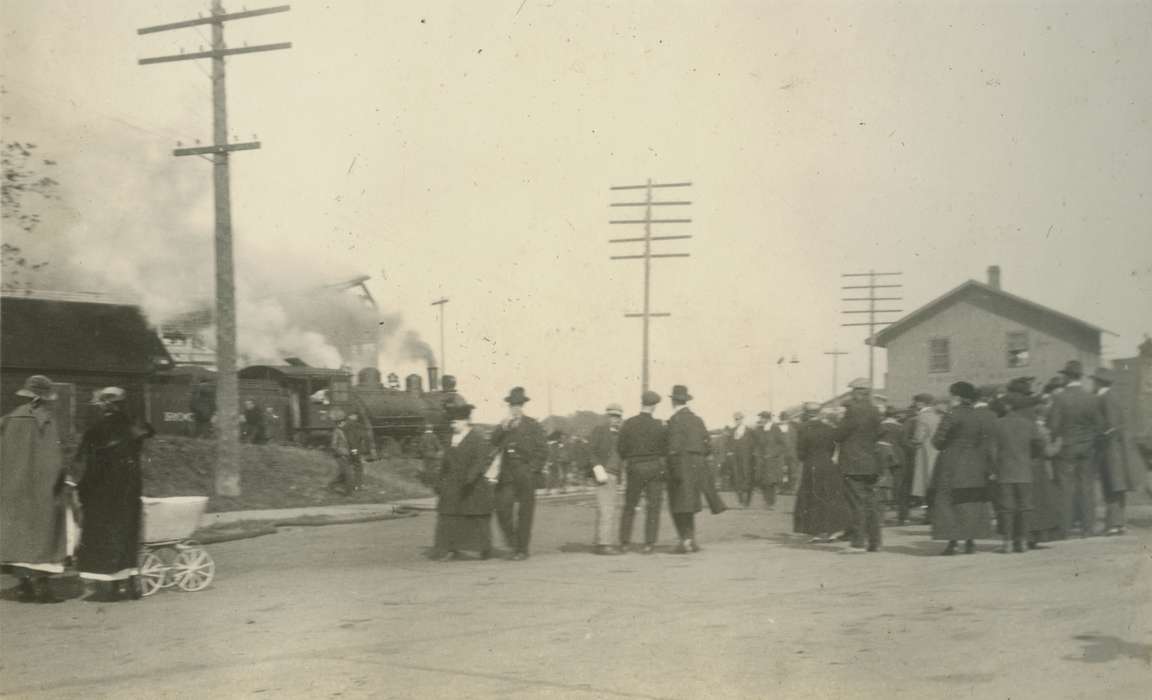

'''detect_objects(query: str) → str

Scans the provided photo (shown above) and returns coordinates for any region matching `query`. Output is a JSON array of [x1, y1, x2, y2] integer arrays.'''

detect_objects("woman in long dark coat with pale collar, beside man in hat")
[[434, 404, 495, 561]]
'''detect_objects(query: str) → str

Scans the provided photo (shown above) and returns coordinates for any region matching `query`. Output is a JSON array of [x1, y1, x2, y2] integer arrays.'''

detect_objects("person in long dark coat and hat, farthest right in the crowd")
[[1092, 367, 1146, 535]]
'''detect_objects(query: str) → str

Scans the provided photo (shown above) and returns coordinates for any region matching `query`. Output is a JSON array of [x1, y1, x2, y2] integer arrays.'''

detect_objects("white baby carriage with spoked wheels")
[[139, 496, 215, 595]]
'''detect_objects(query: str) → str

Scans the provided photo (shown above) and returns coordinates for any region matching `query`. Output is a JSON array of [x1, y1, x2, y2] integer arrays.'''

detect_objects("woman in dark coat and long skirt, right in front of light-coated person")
[[932, 381, 995, 555]]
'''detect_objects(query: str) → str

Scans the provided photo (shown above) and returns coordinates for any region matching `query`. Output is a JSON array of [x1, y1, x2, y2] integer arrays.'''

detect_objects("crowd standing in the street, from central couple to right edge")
[[432, 360, 1146, 561]]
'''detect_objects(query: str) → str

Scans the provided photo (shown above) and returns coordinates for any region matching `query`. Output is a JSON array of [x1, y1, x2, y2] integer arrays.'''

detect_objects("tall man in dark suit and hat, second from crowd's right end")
[[1048, 360, 1104, 537]]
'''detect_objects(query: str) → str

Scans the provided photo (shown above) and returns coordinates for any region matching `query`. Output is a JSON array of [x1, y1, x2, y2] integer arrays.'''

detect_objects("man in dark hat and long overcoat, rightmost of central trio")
[[668, 385, 712, 554]]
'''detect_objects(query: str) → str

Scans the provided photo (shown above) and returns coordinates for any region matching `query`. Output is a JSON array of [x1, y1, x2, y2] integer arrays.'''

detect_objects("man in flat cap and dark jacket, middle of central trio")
[[616, 391, 668, 554]]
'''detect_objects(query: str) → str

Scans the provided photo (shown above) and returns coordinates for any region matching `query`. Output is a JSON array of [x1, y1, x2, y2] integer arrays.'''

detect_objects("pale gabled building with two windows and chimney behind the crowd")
[[867, 266, 1104, 406]]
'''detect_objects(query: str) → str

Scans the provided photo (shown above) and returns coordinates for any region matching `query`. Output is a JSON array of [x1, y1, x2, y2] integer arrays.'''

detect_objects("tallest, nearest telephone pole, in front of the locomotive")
[[136, 0, 291, 496]]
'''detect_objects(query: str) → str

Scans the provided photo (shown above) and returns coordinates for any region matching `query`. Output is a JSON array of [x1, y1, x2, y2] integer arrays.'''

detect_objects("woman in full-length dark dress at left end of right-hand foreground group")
[[793, 403, 852, 542]]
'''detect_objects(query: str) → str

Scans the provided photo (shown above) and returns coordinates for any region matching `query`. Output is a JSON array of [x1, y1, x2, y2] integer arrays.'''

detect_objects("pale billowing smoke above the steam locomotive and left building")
[[5, 108, 434, 368]]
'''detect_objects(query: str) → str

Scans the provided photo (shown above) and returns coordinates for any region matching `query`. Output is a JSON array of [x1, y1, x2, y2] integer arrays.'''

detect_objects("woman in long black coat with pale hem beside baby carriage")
[[76, 387, 154, 600]]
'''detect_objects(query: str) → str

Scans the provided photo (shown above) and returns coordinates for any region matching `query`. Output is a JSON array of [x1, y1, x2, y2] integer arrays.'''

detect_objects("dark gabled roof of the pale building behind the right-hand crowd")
[[866, 280, 1105, 349]]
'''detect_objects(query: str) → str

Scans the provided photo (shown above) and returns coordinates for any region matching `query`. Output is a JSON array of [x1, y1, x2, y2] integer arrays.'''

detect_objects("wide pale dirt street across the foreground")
[[0, 499, 1152, 700]]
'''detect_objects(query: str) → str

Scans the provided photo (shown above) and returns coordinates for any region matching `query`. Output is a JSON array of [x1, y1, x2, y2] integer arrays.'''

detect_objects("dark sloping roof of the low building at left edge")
[[0, 296, 172, 375]]
